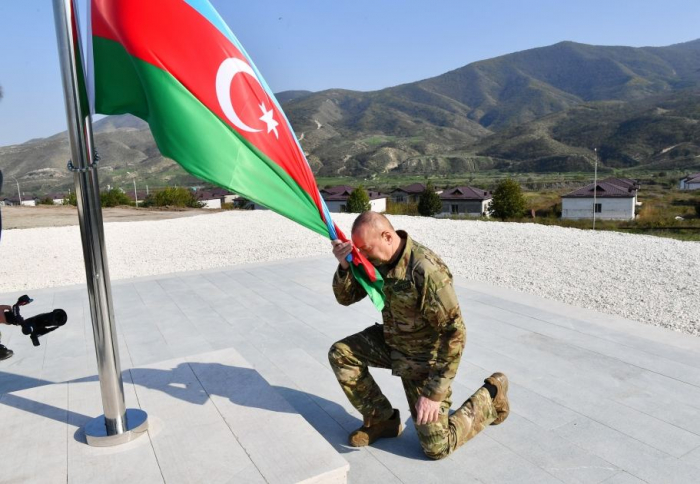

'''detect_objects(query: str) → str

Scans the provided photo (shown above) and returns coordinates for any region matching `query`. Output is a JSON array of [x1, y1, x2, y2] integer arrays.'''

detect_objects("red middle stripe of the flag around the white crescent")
[[92, 0, 325, 217]]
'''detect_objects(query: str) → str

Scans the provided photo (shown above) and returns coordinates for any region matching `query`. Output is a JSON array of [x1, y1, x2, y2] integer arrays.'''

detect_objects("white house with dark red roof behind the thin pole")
[[561, 178, 639, 220]]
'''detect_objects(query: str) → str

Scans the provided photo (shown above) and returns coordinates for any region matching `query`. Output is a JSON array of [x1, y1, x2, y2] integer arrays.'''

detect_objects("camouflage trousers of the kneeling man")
[[328, 324, 496, 459]]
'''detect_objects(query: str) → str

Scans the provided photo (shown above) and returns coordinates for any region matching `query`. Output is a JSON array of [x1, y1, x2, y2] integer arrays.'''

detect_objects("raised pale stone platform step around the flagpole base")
[[0, 348, 349, 484]]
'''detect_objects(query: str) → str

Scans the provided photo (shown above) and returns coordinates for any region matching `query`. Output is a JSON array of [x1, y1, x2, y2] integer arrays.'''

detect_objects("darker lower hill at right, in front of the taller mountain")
[[465, 90, 700, 172]]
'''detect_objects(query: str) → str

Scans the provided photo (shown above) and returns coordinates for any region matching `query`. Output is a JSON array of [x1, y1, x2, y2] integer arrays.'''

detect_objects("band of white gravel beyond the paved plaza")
[[0, 211, 700, 336]]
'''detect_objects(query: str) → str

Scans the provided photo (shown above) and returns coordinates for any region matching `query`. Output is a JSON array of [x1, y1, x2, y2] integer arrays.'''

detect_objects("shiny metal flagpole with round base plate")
[[53, 0, 148, 447]]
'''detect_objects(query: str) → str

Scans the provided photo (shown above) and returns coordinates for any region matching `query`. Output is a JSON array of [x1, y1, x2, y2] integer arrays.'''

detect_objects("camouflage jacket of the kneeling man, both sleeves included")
[[333, 230, 466, 401]]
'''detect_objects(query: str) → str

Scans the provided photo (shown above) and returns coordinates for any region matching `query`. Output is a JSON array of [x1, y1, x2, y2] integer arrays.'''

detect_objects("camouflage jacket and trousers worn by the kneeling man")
[[328, 230, 496, 459]]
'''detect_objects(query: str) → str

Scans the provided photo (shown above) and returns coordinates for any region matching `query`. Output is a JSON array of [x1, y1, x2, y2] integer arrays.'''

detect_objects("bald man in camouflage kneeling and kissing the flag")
[[328, 212, 510, 459]]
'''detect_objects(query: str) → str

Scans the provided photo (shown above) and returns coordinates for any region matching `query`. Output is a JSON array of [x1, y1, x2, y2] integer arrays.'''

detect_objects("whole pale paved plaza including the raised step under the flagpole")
[[0, 255, 700, 484]]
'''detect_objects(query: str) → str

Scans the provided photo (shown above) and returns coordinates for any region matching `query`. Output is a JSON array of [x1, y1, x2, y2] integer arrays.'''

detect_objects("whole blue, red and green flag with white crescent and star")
[[88, 0, 384, 310]]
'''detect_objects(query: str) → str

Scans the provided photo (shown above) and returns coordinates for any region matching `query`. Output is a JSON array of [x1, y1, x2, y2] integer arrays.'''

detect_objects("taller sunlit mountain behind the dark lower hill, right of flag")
[[285, 40, 700, 176]]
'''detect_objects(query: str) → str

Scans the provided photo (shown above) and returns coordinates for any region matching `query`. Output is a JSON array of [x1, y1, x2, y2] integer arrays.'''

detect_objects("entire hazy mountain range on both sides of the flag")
[[0, 39, 700, 196]]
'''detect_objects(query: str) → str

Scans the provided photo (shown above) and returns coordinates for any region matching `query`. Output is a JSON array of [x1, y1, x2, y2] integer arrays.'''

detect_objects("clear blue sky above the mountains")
[[0, 0, 700, 146]]
